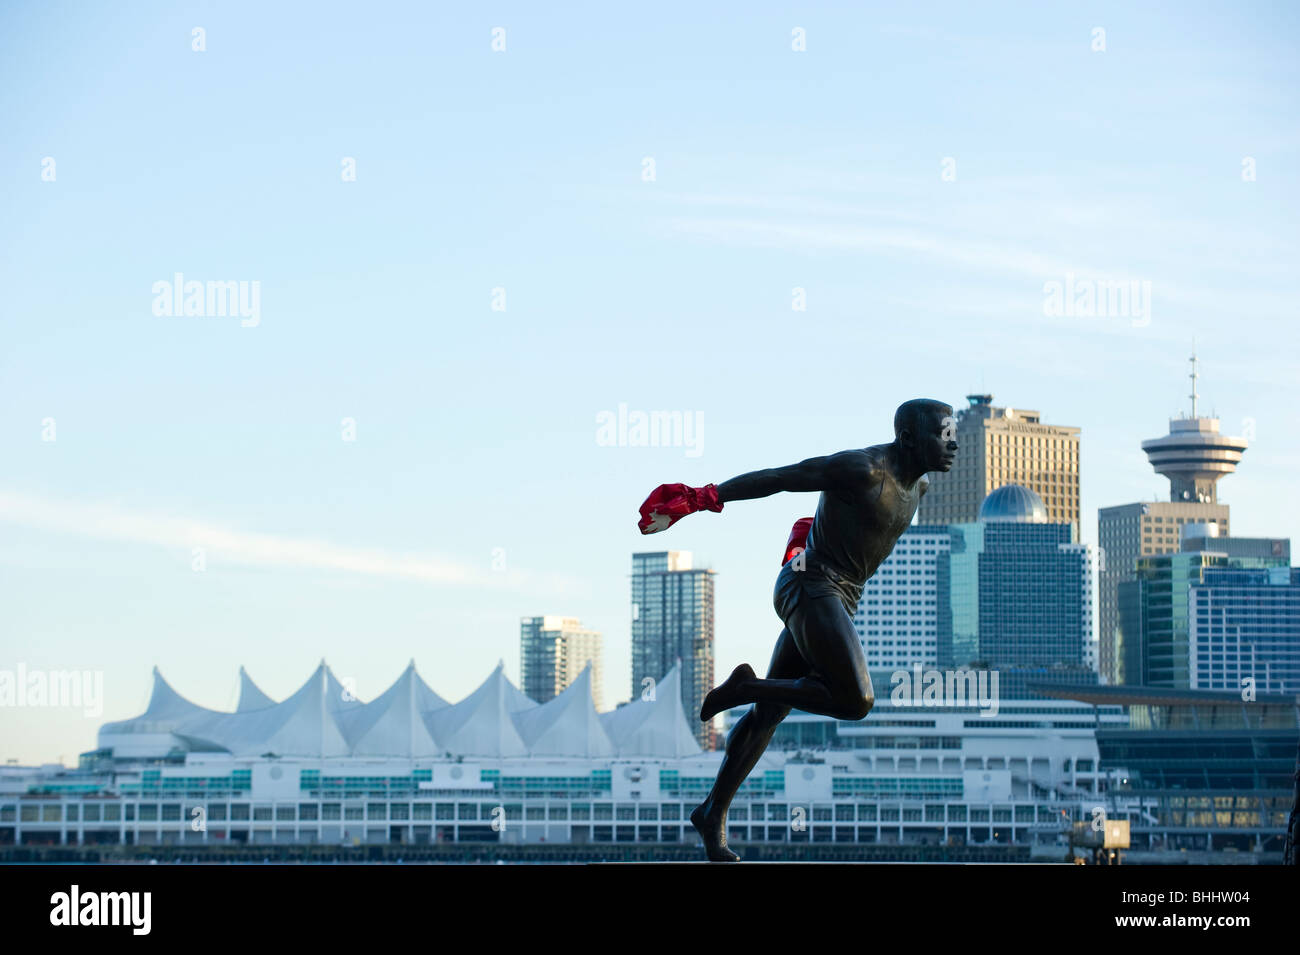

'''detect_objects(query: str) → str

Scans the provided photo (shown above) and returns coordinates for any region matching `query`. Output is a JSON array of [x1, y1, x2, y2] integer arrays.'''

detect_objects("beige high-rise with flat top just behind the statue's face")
[[917, 395, 1079, 528]]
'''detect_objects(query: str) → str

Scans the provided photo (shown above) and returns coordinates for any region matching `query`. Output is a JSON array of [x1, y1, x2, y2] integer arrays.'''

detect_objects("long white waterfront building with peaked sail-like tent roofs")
[[0, 664, 1125, 851]]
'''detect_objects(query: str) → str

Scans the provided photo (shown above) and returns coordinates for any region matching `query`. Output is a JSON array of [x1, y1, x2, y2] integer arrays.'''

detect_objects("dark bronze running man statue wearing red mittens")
[[638, 399, 957, 861]]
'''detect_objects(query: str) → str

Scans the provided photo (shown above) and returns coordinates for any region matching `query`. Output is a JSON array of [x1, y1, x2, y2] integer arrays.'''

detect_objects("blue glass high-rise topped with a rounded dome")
[[936, 485, 1096, 699]]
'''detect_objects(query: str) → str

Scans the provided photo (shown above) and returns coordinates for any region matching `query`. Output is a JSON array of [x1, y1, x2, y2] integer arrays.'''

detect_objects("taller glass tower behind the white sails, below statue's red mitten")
[[632, 551, 715, 750]]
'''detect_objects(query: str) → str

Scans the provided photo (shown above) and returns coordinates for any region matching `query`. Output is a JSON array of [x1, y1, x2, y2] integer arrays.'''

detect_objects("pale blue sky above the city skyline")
[[0, 3, 1300, 761]]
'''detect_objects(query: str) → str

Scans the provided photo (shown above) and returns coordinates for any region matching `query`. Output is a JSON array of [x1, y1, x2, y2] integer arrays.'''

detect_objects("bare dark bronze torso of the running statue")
[[806, 444, 928, 586]]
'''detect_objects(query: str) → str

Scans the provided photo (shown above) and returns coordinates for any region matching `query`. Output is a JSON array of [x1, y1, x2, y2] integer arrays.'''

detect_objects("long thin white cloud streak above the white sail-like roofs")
[[0, 491, 582, 594]]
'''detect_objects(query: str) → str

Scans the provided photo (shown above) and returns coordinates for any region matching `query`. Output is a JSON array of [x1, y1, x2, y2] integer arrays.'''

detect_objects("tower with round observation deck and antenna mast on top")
[[1097, 355, 1245, 683]]
